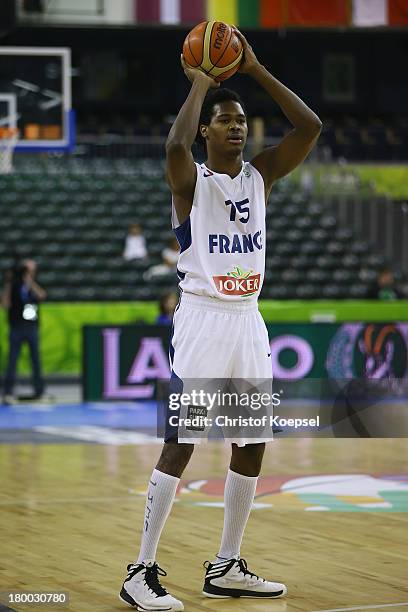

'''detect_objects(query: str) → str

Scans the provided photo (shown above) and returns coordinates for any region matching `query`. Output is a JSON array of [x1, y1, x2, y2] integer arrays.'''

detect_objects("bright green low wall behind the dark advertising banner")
[[0, 300, 408, 375]]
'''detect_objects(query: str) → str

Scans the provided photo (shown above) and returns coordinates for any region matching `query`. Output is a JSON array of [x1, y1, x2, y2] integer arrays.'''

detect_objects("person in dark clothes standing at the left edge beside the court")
[[2, 259, 47, 404]]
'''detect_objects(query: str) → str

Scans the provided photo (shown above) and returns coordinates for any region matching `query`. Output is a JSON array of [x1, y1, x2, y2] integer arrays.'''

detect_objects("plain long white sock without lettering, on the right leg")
[[217, 470, 258, 561]]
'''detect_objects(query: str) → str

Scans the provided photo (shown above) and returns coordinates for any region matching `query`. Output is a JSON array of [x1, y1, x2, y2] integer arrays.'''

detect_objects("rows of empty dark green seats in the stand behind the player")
[[0, 157, 402, 301]]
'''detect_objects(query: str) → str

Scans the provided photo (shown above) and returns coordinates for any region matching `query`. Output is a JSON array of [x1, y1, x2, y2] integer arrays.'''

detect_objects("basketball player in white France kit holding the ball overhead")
[[120, 31, 322, 610]]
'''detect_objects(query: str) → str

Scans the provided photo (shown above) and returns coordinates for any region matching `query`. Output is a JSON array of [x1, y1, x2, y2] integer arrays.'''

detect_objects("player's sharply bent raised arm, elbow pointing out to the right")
[[237, 30, 322, 194]]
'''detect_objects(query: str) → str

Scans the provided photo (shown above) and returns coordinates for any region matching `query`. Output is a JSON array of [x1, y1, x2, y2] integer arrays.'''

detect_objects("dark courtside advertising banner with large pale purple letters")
[[83, 322, 408, 401]]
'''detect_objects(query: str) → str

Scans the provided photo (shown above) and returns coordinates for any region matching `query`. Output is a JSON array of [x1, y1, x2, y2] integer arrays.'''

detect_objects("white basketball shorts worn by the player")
[[165, 293, 272, 446]]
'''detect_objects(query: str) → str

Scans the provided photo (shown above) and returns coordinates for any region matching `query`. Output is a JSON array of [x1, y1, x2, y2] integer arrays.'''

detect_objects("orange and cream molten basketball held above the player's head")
[[183, 21, 243, 81]]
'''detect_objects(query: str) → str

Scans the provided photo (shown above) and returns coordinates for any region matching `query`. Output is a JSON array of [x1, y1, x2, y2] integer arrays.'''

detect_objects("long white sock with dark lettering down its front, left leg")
[[137, 470, 180, 563]]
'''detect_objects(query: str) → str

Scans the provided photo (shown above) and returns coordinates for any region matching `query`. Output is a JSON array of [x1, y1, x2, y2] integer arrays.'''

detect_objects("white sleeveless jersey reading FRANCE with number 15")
[[172, 162, 266, 301]]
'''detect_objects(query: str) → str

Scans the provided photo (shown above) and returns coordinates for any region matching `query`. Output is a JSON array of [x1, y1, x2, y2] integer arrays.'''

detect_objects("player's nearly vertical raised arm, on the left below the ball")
[[166, 56, 219, 223]]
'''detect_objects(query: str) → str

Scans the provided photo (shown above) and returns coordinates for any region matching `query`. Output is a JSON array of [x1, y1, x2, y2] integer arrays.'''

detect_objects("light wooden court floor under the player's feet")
[[0, 439, 408, 612]]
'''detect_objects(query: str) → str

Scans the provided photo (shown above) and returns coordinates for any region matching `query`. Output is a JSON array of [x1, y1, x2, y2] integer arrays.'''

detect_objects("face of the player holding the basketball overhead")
[[203, 100, 248, 154]]
